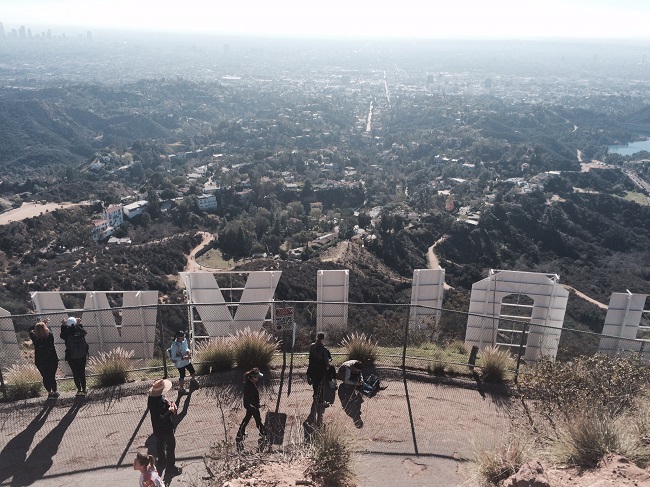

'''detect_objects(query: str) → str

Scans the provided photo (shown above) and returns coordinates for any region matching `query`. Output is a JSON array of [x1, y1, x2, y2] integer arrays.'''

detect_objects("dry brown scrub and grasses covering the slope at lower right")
[[476, 355, 650, 484]]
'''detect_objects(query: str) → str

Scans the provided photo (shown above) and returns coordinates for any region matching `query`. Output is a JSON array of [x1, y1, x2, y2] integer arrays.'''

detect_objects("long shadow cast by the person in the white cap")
[[11, 397, 84, 487]]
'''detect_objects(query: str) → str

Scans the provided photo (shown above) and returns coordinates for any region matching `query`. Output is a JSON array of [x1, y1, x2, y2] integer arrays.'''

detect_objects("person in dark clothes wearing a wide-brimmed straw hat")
[[147, 379, 182, 476]]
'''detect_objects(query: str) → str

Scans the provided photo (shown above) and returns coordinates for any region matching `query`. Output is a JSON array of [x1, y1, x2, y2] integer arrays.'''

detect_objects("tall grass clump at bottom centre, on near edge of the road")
[[305, 423, 354, 487]]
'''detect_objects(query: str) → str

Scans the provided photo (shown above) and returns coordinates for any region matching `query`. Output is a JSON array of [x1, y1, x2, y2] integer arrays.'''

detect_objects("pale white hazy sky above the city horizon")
[[0, 0, 650, 39]]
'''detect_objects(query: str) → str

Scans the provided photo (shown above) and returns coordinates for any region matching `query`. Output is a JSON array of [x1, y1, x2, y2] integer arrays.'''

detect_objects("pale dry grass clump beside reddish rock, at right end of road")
[[474, 435, 530, 485]]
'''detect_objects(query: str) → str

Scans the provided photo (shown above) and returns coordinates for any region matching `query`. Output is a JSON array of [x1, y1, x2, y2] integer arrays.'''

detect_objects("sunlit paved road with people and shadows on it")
[[0, 375, 510, 487]]
